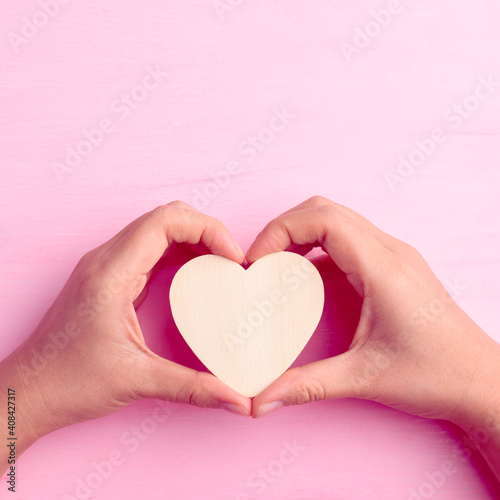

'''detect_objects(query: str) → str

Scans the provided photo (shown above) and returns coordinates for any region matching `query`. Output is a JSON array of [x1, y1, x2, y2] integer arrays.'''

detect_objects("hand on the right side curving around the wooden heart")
[[247, 197, 500, 473]]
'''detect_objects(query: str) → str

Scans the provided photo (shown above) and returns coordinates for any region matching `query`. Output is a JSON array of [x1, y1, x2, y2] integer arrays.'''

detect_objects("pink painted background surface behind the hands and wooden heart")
[[0, 0, 500, 500]]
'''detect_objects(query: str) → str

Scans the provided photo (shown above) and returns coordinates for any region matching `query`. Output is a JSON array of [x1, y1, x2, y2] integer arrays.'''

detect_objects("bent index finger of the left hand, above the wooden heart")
[[104, 205, 245, 291]]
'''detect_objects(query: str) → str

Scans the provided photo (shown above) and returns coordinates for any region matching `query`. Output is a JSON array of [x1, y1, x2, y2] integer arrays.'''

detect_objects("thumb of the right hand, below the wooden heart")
[[252, 351, 358, 418]]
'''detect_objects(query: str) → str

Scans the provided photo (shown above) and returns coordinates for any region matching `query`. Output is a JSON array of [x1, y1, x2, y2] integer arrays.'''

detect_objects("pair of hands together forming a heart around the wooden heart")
[[0, 196, 500, 480]]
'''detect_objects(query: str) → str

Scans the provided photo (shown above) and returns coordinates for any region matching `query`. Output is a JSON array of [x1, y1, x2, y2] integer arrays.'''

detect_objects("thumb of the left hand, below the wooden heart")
[[136, 354, 251, 416]]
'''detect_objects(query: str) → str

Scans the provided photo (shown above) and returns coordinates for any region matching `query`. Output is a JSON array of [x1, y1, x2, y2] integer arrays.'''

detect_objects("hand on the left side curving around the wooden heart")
[[0, 202, 251, 470]]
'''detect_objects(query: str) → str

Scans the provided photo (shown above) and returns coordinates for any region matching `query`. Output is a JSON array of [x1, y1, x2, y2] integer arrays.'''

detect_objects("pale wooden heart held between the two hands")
[[170, 252, 324, 397]]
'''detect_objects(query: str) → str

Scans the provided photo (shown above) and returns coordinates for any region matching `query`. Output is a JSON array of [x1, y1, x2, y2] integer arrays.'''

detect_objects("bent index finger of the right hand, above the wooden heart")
[[247, 204, 390, 296]]
